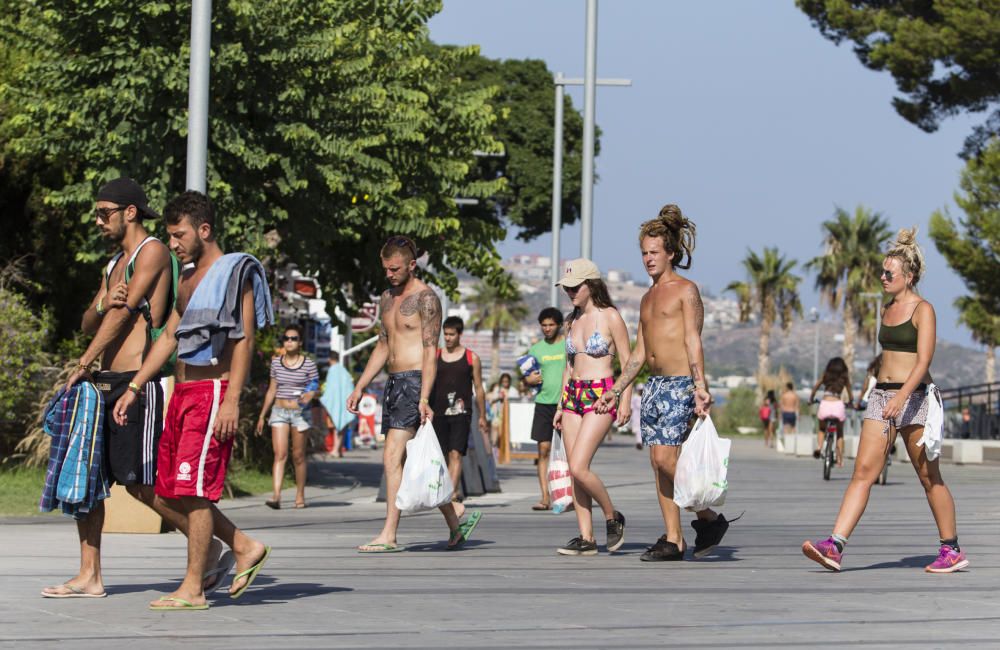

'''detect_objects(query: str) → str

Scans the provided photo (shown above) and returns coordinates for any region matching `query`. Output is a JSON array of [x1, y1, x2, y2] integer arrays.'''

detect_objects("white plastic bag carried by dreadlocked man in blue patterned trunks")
[[674, 415, 732, 512]]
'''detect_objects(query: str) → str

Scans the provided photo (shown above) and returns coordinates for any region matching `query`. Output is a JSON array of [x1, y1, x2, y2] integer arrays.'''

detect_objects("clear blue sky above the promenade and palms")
[[430, 0, 975, 345]]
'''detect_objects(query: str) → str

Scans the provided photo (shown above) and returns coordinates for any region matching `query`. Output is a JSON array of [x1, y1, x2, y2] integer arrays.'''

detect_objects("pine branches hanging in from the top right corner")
[[796, 0, 1000, 157]]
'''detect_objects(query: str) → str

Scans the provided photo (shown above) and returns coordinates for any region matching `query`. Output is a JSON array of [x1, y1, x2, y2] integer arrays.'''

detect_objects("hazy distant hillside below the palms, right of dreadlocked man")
[[704, 322, 985, 387]]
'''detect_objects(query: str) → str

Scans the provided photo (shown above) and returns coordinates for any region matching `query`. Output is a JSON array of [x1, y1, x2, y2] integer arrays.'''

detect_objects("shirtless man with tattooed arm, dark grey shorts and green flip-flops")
[[347, 236, 482, 553]]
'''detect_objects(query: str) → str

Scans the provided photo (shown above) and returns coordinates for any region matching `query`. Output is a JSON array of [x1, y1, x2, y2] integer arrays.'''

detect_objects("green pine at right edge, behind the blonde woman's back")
[[930, 138, 1000, 376]]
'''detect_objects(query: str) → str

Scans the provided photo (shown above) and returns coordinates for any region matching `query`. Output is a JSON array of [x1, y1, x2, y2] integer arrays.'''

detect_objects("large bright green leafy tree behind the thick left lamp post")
[[0, 0, 509, 330]]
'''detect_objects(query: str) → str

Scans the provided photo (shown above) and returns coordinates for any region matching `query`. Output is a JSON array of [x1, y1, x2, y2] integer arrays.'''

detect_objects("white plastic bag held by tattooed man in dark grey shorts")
[[396, 420, 455, 512]]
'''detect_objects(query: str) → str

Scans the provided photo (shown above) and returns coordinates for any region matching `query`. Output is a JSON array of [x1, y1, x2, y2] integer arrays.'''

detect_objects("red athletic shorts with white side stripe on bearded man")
[[156, 379, 233, 501]]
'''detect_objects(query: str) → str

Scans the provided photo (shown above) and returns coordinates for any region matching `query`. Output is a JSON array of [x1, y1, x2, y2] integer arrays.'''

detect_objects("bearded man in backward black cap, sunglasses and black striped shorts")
[[42, 178, 180, 598]]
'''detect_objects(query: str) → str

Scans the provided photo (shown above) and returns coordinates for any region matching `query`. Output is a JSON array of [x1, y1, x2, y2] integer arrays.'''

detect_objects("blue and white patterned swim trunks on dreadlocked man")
[[639, 376, 694, 447]]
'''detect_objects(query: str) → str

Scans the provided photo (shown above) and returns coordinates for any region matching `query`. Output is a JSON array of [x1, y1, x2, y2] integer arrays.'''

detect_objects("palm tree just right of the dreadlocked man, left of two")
[[726, 248, 802, 387]]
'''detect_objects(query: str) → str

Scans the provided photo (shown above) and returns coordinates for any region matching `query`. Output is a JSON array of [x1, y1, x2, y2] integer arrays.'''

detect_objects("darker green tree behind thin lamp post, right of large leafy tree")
[[450, 56, 600, 241]]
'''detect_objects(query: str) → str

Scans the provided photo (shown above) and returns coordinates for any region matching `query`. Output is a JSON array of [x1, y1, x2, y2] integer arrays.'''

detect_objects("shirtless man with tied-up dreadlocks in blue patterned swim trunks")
[[600, 204, 729, 562]]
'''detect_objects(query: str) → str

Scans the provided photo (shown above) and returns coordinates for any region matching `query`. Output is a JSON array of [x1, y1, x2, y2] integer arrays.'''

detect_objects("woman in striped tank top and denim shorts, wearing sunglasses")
[[257, 325, 319, 510]]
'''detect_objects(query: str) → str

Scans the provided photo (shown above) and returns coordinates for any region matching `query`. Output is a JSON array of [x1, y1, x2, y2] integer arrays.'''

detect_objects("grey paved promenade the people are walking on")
[[0, 437, 1000, 650]]
